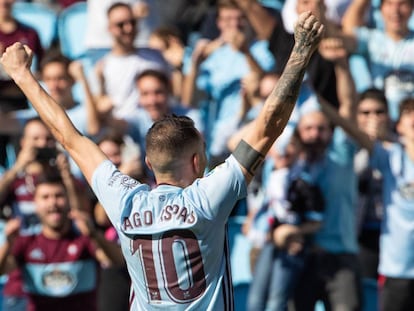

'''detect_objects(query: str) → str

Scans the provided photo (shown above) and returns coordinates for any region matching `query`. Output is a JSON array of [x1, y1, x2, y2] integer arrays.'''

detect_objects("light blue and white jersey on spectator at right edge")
[[371, 143, 414, 279]]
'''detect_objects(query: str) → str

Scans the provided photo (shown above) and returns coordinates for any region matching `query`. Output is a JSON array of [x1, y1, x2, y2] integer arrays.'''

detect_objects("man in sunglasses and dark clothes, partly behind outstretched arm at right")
[[355, 89, 397, 279]]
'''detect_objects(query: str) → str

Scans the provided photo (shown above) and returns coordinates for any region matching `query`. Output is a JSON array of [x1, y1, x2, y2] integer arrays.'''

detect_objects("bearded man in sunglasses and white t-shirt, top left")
[[96, 3, 170, 118]]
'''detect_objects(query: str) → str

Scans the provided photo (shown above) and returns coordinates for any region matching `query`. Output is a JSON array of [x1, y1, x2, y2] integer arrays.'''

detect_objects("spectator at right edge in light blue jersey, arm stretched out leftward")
[[326, 90, 414, 310]]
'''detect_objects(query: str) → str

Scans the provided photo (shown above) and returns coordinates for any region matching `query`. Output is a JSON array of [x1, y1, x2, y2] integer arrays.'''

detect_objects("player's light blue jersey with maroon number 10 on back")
[[92, 156, 247, 310]]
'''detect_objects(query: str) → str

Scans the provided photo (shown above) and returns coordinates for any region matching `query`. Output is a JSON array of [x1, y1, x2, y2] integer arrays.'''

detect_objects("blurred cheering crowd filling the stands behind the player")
[[0, 0, 414, 311]]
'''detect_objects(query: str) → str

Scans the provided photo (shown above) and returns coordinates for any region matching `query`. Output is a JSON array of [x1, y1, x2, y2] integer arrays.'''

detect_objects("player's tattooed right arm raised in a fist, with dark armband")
[[233, 12, 323, 181]]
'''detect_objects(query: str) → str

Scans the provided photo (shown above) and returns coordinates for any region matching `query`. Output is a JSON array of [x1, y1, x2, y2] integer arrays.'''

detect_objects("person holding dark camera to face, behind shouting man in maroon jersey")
[[0, 118, 90, 310]]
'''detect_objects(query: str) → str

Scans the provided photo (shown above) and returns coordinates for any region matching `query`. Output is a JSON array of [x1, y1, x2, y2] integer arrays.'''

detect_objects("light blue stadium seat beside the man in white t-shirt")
[[58, 2, 87, 59]]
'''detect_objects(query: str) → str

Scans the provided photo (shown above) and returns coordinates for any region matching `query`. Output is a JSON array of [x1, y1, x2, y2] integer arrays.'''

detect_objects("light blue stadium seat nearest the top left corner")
[[13, 2, 58, 50]]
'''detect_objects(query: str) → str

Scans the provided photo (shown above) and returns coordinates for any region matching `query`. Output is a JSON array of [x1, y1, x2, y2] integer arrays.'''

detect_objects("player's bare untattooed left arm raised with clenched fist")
[[0, 42, 106, 182]]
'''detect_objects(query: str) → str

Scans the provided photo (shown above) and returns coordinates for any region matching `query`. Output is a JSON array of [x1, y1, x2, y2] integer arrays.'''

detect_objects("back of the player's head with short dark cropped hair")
[[146, 115, 203, 173]]
